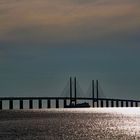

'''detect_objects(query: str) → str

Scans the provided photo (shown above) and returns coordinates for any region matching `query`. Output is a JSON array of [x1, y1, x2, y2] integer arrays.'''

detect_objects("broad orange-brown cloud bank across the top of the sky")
[[0, 0, 140, 42]]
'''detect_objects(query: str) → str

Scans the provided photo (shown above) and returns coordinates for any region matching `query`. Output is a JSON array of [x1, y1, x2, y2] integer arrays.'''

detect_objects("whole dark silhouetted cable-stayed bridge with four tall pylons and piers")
[[0, 77, 140, 110]]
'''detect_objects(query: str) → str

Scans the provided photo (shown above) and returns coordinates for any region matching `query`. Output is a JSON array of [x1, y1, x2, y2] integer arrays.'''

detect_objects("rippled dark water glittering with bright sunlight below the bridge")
[[0, 108, 140, 140]]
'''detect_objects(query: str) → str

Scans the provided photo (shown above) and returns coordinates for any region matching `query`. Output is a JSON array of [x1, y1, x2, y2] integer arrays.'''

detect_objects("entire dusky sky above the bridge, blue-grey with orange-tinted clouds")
[[0, 0, 140, 99]]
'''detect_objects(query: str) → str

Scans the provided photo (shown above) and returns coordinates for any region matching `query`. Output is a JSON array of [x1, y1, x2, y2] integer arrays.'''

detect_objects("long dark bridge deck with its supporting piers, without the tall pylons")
[[0, 97, 140, 110]]
